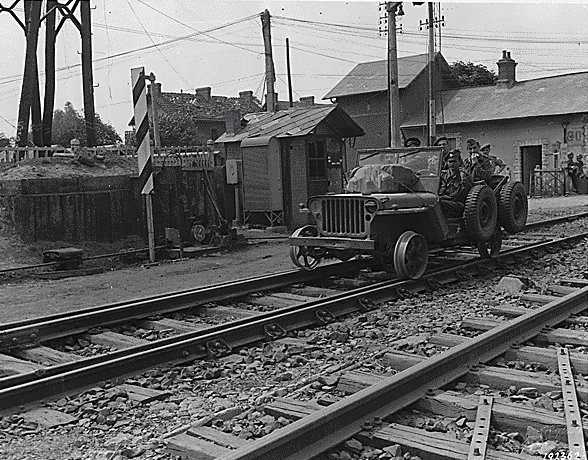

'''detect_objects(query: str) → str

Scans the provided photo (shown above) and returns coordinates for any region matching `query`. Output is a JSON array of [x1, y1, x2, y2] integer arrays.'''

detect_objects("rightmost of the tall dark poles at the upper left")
[[80, 0, 96, 147]]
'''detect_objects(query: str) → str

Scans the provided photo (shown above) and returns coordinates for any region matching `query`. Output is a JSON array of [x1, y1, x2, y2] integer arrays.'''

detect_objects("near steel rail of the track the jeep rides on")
[[0, 233, 588, 410]]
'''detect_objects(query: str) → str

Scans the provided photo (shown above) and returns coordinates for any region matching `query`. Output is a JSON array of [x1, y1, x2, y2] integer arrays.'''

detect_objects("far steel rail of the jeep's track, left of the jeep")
[[0, 259, 374, 350]]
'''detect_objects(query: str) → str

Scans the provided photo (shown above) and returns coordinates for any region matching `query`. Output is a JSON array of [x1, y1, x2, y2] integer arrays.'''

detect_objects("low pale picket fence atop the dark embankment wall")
[[0, 145, 218, 170]]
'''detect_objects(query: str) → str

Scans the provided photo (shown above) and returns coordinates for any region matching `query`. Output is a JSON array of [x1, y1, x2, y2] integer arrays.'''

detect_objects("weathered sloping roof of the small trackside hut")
[[215, 104, 365, 143]]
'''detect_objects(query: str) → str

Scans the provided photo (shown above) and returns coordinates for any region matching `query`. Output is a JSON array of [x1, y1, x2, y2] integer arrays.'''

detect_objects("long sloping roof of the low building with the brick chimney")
[[402, 72, 588, 127]]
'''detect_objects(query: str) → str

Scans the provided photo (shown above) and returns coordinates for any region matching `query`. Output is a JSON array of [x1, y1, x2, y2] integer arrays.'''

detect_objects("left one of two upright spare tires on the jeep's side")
[[463, 185, 498, 241]]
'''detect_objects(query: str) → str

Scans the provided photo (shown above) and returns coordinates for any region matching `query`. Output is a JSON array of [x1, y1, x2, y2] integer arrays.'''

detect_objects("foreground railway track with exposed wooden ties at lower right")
[[215, 280, 588, 460]]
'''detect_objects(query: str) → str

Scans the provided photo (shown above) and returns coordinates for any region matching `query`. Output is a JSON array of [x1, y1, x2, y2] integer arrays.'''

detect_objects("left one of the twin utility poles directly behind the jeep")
[[386, 2, 404, 148]]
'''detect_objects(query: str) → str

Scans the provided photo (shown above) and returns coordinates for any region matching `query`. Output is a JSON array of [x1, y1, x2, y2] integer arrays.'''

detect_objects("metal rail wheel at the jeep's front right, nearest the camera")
[[394, 230, 429, 280]]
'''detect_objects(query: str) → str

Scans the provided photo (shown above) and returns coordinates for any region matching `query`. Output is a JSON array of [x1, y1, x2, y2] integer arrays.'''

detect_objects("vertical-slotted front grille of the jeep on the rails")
[[319, 197, 369, 237]]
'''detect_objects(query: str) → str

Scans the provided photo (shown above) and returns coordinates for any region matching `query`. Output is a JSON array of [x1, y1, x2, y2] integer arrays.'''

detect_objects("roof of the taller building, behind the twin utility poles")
[[323, 53, 438, 99]]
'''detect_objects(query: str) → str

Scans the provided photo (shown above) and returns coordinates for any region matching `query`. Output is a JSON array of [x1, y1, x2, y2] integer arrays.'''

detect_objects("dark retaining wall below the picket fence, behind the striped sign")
[[0, 166, 234, 242]]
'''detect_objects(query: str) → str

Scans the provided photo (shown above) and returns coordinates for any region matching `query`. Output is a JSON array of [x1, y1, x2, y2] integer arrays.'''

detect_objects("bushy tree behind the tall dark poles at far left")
[[51, 101, 121, 147]]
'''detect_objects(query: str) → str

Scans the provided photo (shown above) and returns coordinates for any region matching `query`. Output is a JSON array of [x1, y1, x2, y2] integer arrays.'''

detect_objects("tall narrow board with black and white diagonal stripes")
[[131, 67, 153, 195]]
